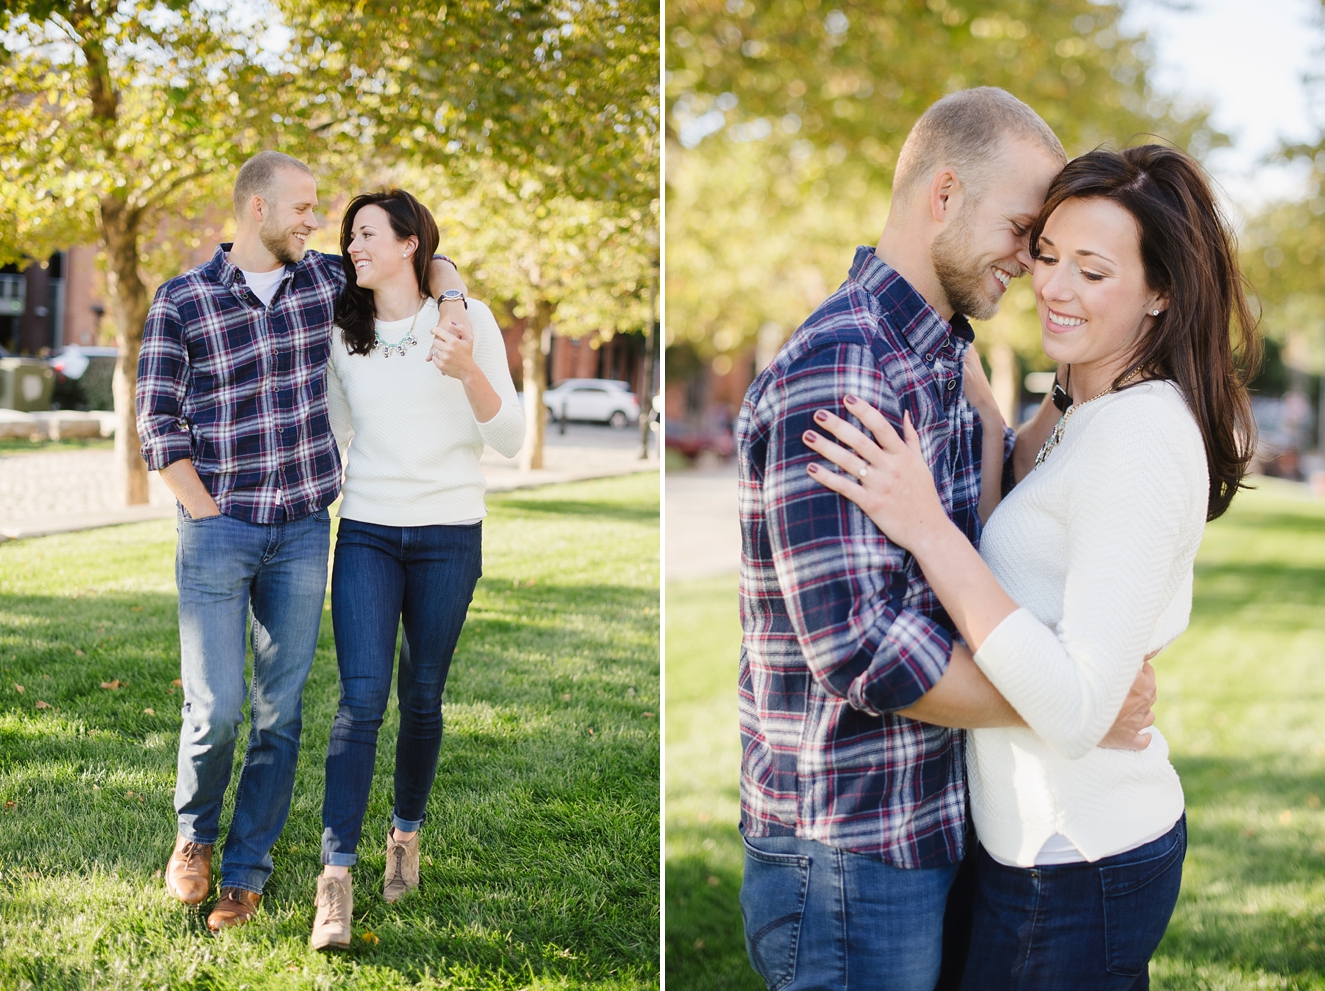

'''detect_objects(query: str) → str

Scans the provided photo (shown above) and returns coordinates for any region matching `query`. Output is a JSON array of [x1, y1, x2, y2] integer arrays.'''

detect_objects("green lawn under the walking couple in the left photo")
[[0, 474, 660, 991]]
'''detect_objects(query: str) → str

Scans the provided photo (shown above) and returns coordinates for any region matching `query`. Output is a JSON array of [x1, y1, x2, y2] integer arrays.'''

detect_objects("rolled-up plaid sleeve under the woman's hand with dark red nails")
[[761, 344, 953, 715]]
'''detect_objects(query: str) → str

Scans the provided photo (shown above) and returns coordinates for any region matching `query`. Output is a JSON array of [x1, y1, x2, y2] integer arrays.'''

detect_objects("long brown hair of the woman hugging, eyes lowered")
[[1031, 144, 1261, 519]]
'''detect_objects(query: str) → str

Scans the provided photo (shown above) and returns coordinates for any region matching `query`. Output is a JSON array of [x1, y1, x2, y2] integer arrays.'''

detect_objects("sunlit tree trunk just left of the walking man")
[[101, 196, 147, 506]]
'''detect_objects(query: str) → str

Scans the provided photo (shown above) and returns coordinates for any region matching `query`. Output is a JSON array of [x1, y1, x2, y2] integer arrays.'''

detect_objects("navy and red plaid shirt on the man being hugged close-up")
[[737, 248, 1015, 868]]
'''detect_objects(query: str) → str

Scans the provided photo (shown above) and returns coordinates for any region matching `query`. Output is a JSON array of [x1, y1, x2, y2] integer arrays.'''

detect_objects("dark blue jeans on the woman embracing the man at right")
[[962, 816, 1187, 991]]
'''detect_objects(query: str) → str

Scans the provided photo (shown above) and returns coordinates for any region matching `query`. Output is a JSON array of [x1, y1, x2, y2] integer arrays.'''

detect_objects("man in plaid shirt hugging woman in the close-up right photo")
[[738, 87, 1146, 991]]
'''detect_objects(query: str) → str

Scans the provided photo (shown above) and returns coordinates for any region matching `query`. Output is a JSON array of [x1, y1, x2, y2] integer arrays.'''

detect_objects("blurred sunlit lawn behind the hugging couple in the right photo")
[[665, 480, 1325, 991]]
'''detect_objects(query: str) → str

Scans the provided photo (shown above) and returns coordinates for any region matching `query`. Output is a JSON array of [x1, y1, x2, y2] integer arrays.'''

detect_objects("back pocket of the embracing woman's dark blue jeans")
[[1100, 819, 1187, 978]]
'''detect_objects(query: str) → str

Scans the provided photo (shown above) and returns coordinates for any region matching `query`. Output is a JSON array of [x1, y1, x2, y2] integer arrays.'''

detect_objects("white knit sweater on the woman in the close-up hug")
[[967, 382, 1208, 866]]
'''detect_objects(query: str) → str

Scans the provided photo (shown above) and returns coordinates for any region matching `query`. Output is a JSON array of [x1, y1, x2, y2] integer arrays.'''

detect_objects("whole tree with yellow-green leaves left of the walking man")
[[0, 0, 279, 503]]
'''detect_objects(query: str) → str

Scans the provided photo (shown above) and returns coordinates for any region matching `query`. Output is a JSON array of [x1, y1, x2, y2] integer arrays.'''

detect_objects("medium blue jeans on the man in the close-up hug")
[[741, 836, 957, 991]]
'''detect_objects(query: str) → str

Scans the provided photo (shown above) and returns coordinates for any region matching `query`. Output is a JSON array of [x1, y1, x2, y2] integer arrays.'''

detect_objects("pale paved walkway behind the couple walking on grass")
[[0, 424, 659, 541]]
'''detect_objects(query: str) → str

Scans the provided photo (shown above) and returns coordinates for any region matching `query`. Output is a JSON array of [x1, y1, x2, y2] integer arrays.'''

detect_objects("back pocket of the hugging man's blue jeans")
[[741, 841, 810, 991]]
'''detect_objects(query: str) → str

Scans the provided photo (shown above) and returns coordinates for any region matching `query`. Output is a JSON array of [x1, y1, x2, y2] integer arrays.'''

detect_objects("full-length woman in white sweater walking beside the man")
[[313, 189, 525, 949]]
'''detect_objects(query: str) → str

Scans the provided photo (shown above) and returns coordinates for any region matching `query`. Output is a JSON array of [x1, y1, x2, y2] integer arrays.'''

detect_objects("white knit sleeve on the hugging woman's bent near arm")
[[975, 401, 1206, 758]]
